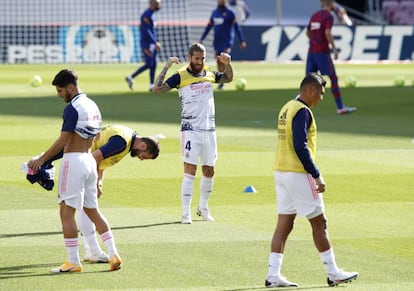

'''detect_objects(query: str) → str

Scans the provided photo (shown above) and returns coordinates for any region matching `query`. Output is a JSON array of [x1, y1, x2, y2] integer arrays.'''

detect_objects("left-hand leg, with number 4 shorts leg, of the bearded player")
[[181, 131, 200, 224]]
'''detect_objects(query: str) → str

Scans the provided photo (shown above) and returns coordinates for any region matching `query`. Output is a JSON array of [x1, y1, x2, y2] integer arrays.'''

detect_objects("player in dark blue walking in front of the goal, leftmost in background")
[[125, 0, 161, 91]]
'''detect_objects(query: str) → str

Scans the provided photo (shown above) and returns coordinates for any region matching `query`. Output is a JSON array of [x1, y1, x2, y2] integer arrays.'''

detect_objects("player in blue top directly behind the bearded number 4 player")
[[199, 0, 247, 89]]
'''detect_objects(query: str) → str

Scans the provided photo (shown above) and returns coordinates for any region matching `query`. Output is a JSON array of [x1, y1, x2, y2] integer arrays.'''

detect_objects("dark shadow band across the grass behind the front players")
[[0, 87, 414, 137]]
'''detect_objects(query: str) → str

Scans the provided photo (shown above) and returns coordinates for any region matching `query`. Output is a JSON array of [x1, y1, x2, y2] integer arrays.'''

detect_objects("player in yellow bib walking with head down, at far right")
[[265, 73, 358, 288]]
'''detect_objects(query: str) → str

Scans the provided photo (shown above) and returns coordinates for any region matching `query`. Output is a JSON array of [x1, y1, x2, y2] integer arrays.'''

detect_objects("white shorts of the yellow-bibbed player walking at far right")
[[274, 171, 325, 219]]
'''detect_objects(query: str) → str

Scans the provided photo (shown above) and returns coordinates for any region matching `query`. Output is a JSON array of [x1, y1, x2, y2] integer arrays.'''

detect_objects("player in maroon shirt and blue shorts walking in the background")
[[306, 0, 356, 114]]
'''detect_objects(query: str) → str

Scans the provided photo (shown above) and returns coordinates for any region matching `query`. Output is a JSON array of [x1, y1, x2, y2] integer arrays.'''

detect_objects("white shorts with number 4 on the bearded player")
[[181, 131, 217, 167]]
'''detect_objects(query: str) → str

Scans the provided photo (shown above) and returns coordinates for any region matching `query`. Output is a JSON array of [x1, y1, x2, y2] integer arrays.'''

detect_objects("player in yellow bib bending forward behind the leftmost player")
[[78, 125, 159, 263]]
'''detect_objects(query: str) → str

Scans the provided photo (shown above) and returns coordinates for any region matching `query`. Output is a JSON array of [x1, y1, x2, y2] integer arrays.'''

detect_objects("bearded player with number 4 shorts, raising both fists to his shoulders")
[[154, 43, 233, 224]]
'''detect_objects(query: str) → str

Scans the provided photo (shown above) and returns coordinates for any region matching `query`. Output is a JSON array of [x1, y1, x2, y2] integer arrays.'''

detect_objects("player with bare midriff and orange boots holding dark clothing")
[[28, 69, 122, 273]]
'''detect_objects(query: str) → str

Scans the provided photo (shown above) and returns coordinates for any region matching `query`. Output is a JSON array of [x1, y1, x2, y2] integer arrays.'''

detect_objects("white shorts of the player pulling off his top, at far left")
[[58, 153, 98, 209]]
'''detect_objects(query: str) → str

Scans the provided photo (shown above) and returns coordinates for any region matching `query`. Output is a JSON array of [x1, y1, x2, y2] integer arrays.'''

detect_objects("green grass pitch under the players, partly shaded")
[[0, 63, 414, 290]]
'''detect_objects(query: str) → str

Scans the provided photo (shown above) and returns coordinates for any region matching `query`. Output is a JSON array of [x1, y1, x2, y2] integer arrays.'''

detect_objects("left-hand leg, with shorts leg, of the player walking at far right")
[[265, 171, 298, 287]]
